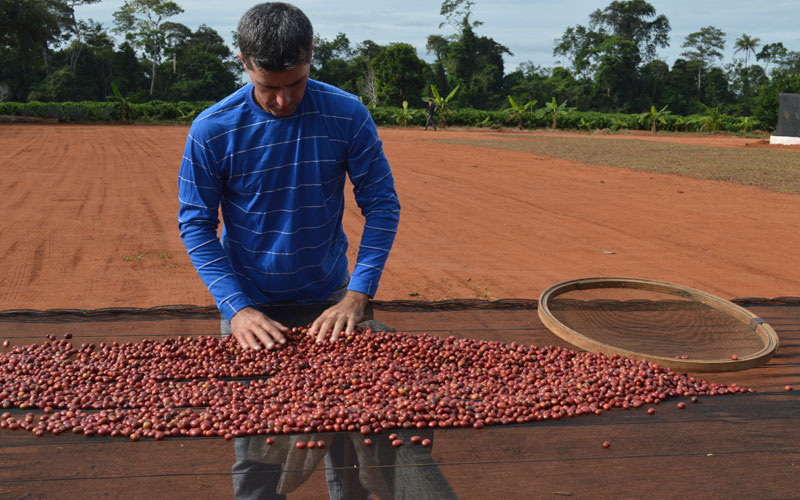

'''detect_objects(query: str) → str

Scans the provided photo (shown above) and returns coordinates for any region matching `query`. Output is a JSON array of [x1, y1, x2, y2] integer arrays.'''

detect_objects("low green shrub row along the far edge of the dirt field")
[[0, 101, 758, 132]]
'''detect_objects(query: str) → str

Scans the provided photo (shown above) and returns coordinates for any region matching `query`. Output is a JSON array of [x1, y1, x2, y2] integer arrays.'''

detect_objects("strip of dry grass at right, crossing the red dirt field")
[[435, 136, 800, 194]]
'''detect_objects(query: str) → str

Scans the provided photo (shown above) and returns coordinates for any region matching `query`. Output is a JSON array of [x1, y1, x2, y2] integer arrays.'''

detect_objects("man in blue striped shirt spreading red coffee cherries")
[[178, 3, 400, 498]]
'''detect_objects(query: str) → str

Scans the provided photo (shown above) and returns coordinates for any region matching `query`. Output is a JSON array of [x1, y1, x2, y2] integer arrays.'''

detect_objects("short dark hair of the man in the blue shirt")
[[236, 2, 314, 71]]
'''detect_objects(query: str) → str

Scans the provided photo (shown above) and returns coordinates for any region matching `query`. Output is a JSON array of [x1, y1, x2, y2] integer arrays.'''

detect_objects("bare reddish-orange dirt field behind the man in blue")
[[0, 124, 800, 309]]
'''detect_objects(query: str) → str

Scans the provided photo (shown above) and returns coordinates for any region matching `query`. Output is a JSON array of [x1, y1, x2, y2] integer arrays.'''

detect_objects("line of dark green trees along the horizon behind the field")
[[0, 0, 800, 126]]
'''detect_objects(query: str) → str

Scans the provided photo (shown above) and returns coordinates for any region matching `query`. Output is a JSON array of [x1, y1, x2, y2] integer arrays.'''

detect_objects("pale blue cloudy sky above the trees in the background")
[[76, 0, 800, 71]]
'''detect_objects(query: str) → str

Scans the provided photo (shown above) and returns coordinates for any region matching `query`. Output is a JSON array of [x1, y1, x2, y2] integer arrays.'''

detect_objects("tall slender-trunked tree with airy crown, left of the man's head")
[[114, 0, 183, 96]]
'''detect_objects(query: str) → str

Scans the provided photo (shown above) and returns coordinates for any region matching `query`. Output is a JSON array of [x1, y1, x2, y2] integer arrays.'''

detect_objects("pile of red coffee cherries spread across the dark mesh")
[[0, 328, 752, 440]]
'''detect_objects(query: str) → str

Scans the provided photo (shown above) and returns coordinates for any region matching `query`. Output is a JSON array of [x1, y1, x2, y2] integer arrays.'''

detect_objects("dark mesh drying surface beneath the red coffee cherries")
[[0, 298, 800, 499]]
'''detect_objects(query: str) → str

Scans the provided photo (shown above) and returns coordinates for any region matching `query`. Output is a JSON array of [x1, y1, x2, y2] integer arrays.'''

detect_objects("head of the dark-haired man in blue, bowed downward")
[[237, 2, 314, 117]]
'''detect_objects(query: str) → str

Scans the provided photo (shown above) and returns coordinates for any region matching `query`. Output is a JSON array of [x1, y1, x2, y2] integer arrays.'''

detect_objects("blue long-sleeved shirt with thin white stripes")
[[178, 79, 400, 320]]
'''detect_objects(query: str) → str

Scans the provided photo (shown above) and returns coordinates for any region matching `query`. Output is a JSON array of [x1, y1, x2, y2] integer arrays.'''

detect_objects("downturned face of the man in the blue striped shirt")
[[239, 54, 311, 117]]
